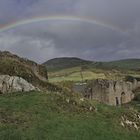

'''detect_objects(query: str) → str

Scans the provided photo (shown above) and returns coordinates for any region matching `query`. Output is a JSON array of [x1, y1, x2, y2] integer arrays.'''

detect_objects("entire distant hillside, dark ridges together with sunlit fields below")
[[45, 58, 140, 82]]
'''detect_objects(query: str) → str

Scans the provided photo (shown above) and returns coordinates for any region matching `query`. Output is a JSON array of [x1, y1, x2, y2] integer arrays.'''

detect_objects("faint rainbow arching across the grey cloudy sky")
[[0, 16, 124, 32]]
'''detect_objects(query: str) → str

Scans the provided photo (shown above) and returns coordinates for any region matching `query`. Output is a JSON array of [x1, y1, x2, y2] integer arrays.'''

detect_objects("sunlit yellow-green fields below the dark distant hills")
[[48, 67, 140, 82]]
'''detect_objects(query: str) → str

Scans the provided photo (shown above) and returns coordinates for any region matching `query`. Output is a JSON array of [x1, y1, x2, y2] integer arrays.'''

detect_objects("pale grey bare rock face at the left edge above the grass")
[[0, 75, 39, 94]]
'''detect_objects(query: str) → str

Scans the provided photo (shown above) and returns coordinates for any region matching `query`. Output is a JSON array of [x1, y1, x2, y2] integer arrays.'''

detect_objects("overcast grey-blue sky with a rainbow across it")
[[0, 0, 140, 63]]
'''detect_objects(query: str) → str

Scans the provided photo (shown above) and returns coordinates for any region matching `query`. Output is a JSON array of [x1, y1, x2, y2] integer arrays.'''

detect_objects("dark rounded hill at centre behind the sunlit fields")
[[43, 57, 93, 71]]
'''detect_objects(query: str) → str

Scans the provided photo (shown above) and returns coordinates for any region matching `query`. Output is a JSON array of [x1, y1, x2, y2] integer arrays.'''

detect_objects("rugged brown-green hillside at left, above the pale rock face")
[[0, 51, 48, 85]]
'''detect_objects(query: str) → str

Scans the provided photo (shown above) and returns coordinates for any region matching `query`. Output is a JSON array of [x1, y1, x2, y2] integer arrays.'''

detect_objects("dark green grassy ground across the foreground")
[[0, 92, 140, 140]]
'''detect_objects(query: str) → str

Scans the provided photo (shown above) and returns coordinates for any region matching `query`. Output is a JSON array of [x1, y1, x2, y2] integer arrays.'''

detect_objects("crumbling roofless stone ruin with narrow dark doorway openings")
[[83, 79, 140, 106]]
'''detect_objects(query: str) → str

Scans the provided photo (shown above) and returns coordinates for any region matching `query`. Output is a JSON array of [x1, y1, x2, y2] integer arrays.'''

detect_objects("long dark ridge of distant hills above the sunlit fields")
[[43, 57, 140, 71]]
